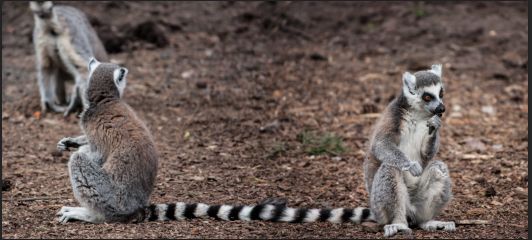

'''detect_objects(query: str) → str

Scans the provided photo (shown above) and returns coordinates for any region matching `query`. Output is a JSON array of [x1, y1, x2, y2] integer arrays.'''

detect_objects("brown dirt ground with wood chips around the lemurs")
[[2, 2, 528, 238]]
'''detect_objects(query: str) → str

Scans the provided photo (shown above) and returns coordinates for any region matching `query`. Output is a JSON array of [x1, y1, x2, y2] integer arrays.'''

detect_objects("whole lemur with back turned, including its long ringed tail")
[[57, 59, 372, 223]]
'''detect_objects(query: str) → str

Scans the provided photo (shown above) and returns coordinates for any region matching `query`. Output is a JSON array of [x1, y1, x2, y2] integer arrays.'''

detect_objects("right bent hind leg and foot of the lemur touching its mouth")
[[411, 161, 455, 231]]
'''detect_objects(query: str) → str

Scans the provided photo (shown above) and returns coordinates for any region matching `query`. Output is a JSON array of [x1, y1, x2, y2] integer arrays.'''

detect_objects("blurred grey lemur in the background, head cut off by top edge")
[[30, 1, 108, 116]]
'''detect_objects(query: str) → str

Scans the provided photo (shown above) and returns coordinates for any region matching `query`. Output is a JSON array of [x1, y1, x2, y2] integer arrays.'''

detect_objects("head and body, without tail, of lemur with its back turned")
[[57, 59, 158, 223]]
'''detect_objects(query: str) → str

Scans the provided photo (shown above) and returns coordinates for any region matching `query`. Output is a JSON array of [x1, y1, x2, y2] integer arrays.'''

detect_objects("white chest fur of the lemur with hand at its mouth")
[[399, 115, 429, 186]]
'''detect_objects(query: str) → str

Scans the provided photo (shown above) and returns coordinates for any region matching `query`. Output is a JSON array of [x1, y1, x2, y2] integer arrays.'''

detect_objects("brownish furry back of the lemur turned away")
[[81, 100, 158, 203]]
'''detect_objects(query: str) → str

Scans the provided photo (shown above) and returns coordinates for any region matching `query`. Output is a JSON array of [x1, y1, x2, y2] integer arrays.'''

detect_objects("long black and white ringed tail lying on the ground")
[[141, 202, 374, 223]]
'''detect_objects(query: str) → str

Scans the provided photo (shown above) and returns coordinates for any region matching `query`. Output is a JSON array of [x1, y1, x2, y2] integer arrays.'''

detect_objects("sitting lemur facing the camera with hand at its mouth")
[[364, 65, 455, 236]]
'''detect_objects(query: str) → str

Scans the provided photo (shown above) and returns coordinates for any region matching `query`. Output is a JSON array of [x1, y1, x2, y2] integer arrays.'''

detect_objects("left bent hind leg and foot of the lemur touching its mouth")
[[370, 164, 412, 237]]
